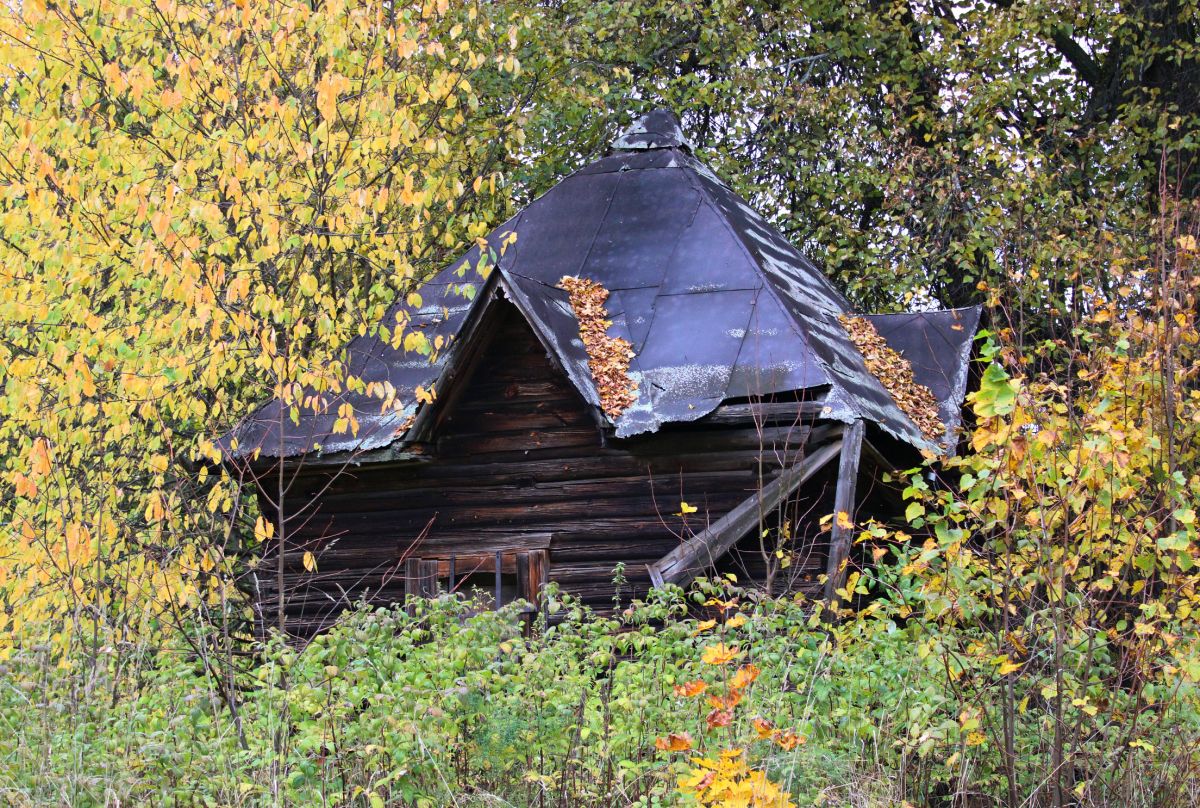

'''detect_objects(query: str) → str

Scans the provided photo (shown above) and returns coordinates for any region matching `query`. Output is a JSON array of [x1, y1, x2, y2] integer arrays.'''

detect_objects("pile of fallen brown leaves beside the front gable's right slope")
[[558, 275, 637, 420]]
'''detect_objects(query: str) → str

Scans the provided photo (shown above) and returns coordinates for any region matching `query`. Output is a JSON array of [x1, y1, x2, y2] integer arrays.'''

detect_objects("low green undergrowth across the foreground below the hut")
[[0, 573, 1200, 807]]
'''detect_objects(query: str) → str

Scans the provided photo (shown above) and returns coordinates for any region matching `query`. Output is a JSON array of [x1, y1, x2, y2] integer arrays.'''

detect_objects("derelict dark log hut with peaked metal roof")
[[224, 110, 979, 634]]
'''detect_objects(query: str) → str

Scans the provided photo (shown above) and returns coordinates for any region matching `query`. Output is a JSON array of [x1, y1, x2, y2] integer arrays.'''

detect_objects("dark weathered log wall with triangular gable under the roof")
[[250, 304, 829, 635]]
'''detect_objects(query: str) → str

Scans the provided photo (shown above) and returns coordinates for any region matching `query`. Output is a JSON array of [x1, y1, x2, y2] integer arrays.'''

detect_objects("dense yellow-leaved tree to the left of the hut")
[[0, 0, 517, 654]]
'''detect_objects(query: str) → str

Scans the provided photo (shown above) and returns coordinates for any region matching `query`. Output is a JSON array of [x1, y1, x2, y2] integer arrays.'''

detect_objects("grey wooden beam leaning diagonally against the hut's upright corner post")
[[647, 441, 841, 587]]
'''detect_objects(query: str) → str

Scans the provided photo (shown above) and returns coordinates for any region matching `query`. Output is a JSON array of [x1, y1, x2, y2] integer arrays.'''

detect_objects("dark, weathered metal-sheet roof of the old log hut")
[[222, 109, 979, 456]]
